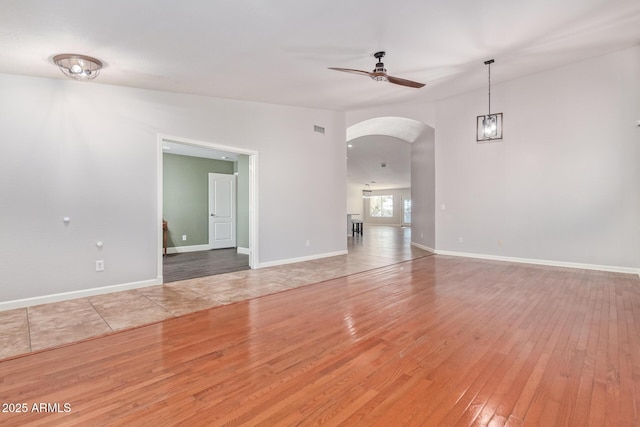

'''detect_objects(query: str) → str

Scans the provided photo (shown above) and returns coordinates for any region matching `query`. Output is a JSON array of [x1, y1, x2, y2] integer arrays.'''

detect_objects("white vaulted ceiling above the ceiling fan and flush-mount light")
[[0, 0, 640, 110]]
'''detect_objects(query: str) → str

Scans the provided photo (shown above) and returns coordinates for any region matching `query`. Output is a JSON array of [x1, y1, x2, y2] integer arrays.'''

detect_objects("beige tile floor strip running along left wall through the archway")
[[0, 226, 430, 359]]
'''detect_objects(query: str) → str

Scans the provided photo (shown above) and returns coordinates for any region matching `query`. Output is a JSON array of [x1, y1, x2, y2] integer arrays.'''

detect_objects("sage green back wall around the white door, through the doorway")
[[162, 153, 234, 247]]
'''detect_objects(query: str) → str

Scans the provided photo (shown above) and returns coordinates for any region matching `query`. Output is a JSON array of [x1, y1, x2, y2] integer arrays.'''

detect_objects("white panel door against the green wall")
[[209, 173, 236, 249]]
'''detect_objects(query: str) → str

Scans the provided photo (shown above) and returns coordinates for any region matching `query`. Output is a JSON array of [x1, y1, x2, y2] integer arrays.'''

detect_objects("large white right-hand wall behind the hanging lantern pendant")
[[436, 47, 640, 268]]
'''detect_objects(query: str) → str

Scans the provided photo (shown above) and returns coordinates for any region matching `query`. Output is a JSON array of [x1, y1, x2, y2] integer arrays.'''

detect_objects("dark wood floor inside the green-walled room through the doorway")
[[162, 248, 249, 283]]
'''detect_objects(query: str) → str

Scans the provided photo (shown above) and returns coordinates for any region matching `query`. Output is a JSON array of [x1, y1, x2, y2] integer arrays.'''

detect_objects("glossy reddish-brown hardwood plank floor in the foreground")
[[0, 256, 640, 426]]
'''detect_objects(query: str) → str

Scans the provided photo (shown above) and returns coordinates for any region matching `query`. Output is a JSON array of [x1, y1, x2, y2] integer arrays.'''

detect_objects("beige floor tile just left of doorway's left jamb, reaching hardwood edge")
[[89, 290, 174, 330]]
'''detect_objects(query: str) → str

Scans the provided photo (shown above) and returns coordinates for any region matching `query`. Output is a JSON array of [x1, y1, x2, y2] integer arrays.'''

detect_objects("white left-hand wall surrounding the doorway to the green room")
[[0, 75, 346, 306]]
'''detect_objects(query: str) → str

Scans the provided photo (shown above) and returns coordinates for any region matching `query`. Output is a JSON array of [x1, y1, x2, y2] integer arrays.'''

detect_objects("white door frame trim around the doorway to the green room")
[[156, 134, 260, 283]]
